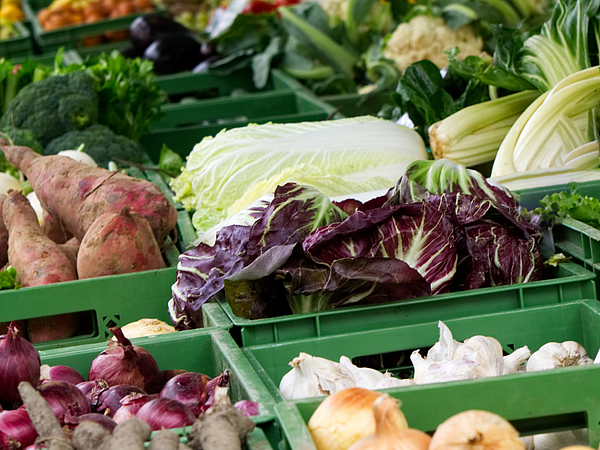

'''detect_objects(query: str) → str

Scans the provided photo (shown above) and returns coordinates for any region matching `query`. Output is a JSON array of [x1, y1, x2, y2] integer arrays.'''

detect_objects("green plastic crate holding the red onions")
[[40, 329, 276, 440]]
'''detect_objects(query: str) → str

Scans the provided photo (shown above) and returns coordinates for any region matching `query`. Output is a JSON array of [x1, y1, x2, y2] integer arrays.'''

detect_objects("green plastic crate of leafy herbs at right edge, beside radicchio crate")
[[515, 181, 600, 295]]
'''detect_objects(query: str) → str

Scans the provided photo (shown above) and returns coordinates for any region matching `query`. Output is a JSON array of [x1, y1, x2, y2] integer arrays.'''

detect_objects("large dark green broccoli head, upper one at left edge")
[[0, 71, 98, 145]]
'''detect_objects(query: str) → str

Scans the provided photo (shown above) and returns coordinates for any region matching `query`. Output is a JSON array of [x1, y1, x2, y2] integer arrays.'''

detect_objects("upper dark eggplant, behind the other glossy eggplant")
[[129, 13, 195, 53]]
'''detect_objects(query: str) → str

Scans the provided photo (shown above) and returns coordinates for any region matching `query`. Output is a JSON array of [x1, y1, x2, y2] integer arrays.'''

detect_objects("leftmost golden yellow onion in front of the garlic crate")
[[308, 388, 408, 450]]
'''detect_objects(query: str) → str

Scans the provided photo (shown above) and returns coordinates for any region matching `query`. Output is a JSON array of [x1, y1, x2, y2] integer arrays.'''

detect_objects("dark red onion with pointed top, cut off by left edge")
[[0, 322, 41, 409]]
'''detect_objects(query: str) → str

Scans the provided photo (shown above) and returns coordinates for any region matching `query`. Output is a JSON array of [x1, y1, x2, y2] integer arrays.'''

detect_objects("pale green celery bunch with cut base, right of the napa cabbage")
[[429, 91, 540, 166]]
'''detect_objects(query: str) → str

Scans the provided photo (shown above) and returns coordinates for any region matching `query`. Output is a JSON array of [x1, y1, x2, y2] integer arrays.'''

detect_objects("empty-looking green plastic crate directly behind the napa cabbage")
[[140, 90, 335, 161]]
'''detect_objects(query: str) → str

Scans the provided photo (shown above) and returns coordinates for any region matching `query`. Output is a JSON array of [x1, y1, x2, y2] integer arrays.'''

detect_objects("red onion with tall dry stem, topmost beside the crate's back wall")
[[88, 327, 159, 389]]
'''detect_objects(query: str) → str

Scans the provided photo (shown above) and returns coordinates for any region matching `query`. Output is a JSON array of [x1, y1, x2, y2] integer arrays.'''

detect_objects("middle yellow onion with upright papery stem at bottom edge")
[[349, 394, 431, 450]]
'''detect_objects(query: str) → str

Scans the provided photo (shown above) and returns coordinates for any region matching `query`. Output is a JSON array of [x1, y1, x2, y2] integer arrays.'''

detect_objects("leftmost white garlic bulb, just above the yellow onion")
[[279, 353, 355, 400]]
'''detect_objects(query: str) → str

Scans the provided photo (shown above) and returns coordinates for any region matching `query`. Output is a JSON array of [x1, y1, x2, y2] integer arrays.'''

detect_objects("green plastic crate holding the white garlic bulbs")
[[264, 300, 600, 450]]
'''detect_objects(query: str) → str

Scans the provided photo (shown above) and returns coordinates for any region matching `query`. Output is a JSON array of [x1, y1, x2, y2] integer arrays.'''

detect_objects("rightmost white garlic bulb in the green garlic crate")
[[525, 341, 593, 372]]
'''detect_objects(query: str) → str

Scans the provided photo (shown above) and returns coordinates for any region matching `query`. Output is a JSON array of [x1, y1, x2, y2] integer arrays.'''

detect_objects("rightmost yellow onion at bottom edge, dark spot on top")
[[429, 410, 525, 450]]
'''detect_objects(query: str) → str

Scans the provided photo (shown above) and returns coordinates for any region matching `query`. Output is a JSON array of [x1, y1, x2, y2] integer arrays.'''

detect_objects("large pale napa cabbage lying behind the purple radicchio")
[[171, 116, 428, 231]]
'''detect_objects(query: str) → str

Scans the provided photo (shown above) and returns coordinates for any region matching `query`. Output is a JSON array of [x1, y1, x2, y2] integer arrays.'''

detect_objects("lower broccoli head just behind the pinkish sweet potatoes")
[[44, 124, 144, 168]]
